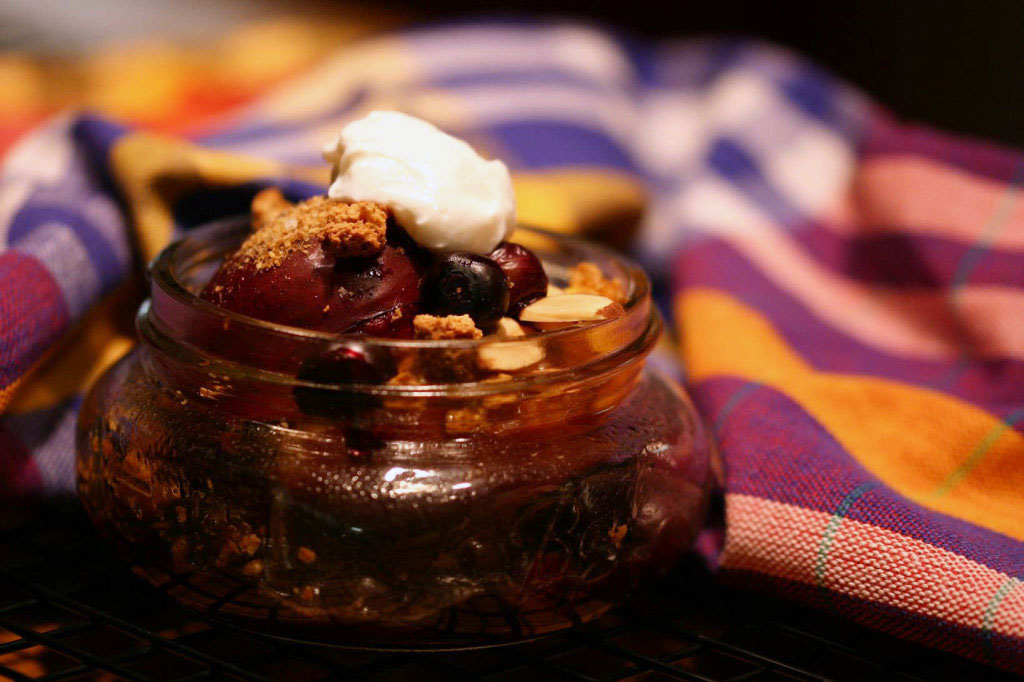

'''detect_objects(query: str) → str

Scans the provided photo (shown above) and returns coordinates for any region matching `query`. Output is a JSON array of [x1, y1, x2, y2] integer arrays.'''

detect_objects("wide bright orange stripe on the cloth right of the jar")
[[676, 289, 1024, 540]]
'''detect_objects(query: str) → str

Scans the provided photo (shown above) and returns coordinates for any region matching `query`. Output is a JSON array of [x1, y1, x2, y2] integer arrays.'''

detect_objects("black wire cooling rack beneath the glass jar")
[[0, 493, 1011, 682]]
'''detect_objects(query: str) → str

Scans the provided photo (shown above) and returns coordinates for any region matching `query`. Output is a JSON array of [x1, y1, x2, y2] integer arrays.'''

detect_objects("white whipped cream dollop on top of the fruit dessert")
[[324, 112, 515, 254]]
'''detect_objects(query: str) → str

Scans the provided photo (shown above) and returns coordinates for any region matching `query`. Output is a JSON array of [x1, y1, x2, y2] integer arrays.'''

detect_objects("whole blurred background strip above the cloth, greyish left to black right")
[[0, 0, 1024, 147]]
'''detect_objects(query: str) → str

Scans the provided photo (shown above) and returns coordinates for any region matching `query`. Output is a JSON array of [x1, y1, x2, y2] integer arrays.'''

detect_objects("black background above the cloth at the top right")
[[415, 0, 1024, 147]]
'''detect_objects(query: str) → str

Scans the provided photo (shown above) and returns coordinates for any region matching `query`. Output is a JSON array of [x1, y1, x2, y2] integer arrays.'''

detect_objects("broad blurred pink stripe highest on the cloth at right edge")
[[851, 157, 1024, 250]]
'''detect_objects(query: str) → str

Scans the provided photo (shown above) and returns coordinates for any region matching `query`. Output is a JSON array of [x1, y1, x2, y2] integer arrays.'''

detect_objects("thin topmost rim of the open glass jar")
[[148, 214, 650, 350]]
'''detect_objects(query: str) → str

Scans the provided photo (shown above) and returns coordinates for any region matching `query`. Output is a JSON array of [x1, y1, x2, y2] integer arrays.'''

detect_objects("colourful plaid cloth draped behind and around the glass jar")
[[0, 19, 1024, 672]]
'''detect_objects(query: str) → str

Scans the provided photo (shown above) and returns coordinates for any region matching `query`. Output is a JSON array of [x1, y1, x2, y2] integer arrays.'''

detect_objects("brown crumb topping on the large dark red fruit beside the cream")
[[231, 193, 387, 270]]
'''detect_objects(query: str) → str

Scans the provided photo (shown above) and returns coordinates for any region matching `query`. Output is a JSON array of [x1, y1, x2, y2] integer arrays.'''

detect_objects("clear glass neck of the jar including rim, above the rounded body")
[[142, 216, 662, 395]]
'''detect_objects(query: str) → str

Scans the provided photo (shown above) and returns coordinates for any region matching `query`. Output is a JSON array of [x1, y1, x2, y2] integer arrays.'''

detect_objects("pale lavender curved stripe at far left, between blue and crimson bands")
[[11, 222, 100, 318]]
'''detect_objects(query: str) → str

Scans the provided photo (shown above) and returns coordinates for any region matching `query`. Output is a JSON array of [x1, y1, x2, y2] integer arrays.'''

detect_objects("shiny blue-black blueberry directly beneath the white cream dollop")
[[423, 251, 509, 333]]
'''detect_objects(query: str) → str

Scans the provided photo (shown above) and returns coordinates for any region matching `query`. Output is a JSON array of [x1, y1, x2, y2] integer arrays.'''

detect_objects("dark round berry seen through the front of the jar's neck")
[[292, 343, 395, 419]]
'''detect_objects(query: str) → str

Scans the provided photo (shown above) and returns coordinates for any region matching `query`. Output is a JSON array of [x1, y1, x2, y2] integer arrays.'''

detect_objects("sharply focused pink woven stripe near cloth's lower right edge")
[[721, 495, 1024, 638]]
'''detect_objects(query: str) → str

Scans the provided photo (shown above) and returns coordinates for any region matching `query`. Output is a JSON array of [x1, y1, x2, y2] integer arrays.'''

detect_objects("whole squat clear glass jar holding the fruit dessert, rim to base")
[[78, 219, 710, 648]]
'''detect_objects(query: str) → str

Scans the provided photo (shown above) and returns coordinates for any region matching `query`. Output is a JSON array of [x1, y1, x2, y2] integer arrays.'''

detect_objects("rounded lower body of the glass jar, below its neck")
[[78, 345, 710, 647]]
